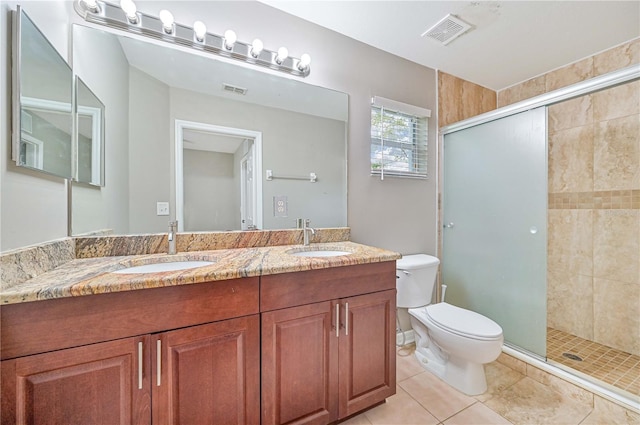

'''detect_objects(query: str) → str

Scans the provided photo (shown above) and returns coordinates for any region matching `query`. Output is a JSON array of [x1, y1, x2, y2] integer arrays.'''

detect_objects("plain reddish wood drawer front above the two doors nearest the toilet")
[[260, 261, 396, 311]]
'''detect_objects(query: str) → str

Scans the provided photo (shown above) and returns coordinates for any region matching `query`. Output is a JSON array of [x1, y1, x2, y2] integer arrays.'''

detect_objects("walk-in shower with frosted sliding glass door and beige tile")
[[441, 65, 640, 406]]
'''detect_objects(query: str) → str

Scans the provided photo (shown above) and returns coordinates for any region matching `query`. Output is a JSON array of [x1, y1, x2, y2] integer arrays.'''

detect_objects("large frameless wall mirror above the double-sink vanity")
[[72, 25, 348, 235]]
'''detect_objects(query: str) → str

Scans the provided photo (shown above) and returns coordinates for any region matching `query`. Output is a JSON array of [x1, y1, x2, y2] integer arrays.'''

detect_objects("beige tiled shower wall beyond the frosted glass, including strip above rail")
[[498, 40, 640, 355]]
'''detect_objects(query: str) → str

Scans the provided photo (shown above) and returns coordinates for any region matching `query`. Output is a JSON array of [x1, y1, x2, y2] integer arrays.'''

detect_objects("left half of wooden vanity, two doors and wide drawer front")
[[0, 278, 260, 425]]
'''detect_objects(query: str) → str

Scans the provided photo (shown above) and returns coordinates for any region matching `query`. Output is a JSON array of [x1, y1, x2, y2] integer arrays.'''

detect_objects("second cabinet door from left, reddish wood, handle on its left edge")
[[151, 314, 260, 425]]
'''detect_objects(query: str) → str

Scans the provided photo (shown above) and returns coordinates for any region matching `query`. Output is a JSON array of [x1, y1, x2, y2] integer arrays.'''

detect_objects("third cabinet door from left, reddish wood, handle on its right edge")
[[262, 301, 339, 425]]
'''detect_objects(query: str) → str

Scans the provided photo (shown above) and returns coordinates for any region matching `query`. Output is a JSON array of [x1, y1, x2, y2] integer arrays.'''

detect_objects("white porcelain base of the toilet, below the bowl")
[[415, 349, 487, 395]]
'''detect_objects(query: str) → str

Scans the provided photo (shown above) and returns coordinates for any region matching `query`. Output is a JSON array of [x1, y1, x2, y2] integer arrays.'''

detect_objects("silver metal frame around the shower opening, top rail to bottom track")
[[436, 64, 640, 407]]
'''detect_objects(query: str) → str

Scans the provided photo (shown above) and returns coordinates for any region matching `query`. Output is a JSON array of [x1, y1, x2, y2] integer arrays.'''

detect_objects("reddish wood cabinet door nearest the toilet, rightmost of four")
[[340, 289, 396, 418]]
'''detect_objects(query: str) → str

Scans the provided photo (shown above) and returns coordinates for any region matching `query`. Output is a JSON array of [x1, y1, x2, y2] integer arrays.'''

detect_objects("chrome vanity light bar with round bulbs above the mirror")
[[74, 0, 311, 77]]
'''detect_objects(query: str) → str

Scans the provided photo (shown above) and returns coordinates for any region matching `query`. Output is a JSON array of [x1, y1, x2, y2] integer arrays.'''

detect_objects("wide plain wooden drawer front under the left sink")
[[0, 277, 259, 360]]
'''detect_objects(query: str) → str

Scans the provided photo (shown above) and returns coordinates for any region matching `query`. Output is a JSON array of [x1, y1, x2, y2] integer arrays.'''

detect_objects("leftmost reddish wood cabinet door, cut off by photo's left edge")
[[2, 337, 151, 425]]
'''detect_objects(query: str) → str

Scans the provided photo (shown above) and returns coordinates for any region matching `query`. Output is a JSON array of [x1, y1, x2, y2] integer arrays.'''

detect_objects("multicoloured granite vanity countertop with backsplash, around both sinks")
[[0, 228, 400, 305]]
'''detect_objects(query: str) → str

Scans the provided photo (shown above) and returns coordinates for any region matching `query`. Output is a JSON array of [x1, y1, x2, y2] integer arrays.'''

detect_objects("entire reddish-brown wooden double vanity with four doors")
[[0, 243, 397, 424]]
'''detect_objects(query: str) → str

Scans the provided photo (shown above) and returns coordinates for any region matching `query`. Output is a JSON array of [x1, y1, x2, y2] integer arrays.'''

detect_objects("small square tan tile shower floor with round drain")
[[547, 328, 640, 395]]
